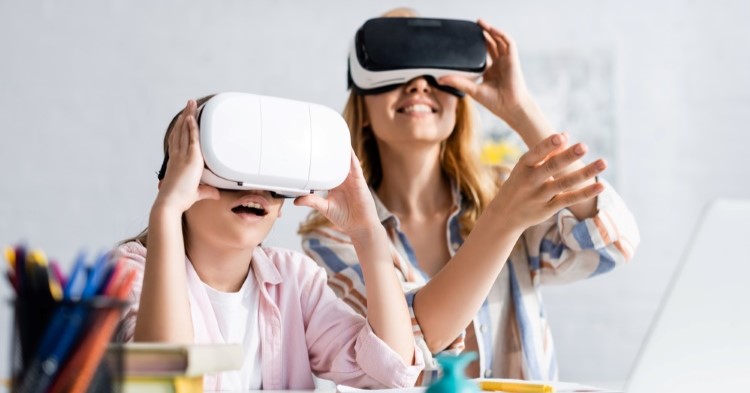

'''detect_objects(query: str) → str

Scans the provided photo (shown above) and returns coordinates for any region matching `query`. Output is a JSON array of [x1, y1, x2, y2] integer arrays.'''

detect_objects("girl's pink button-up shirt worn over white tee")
[[115, 242, 424, 390]]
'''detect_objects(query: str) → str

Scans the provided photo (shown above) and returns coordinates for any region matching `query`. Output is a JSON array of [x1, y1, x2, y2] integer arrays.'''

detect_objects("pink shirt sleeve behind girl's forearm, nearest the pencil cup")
[[113, 242, 146, 342]]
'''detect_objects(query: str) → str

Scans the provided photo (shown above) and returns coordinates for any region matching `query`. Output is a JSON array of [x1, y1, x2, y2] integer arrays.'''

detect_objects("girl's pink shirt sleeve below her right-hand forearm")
[[301, 254, 424, 388]]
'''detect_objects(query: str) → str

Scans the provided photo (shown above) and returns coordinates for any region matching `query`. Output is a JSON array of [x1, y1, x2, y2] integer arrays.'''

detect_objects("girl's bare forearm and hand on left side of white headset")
[[134, 100, 219, 343]]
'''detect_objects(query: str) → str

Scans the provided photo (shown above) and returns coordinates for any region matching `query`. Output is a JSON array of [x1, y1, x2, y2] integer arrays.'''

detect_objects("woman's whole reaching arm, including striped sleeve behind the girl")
[[303, 134, 602, 352]]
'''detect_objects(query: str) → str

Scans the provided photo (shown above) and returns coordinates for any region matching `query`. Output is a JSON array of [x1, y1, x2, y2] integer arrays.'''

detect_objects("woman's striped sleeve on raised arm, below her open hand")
[[524, 179, 640, 285]]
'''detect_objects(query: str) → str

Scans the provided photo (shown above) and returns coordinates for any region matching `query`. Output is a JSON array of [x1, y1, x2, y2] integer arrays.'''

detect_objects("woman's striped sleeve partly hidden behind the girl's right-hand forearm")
[[302, 228, 465, 386]]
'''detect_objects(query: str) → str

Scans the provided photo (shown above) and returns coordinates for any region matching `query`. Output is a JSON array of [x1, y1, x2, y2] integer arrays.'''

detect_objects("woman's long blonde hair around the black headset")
[[298, 8, 505, 238]]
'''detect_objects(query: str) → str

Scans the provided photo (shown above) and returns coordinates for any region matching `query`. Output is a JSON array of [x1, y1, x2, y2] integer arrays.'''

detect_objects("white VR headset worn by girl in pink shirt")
[[159, 93, 351, 197]]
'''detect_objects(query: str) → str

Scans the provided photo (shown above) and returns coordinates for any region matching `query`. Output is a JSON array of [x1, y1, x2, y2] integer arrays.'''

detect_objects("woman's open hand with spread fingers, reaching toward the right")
[[489, 133, 607, 231]]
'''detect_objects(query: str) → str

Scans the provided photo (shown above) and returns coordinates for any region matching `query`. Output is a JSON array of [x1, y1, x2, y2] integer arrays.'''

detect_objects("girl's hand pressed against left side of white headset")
[[154, 100, 219, 213]]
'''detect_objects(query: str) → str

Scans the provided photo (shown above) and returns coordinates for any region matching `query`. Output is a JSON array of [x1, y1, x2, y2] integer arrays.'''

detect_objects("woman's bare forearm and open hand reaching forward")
[[413, 134, 603, 351]]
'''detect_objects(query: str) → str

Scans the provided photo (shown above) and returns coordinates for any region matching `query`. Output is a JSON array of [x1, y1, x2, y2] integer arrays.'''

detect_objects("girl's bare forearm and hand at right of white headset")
[[294, 151, 414, 364]]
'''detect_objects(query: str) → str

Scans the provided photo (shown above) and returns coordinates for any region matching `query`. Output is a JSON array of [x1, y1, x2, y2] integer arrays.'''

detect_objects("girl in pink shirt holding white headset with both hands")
[[117, 97, 423, 390]]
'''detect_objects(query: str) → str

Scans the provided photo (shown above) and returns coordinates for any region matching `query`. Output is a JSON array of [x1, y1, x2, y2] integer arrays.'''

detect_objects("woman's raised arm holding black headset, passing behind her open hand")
[[440, 19, 606, 220]]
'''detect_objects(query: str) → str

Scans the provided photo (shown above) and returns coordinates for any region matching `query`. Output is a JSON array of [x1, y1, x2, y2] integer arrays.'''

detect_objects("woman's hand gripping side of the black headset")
[[438, 19, 531, 124]]
